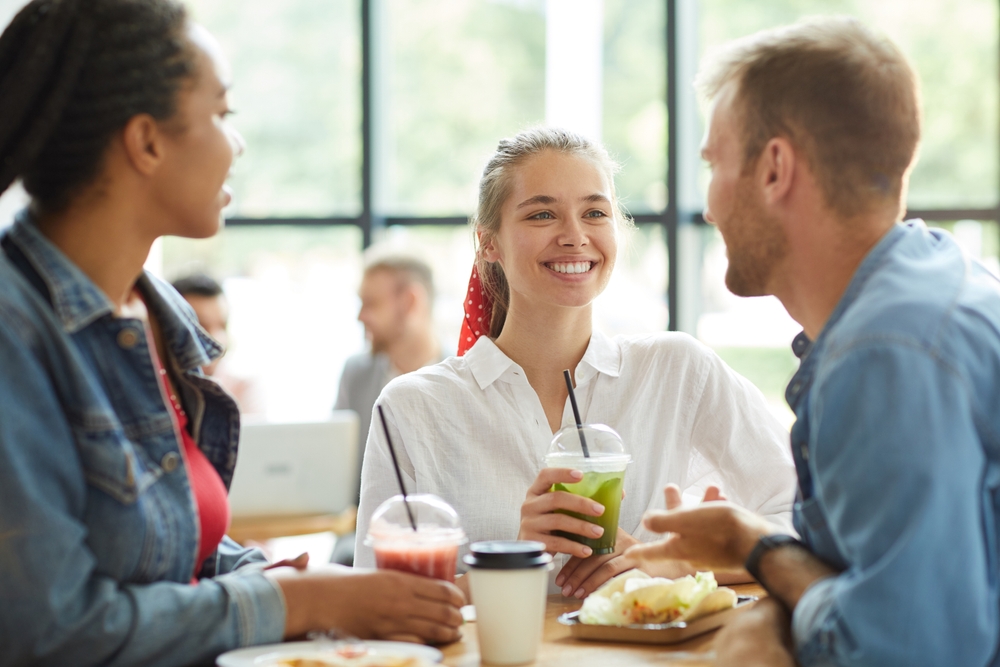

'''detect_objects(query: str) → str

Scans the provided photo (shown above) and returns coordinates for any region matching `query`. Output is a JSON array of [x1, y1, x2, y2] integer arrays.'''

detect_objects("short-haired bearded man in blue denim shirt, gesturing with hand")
[[629, 18, 1000, 667]]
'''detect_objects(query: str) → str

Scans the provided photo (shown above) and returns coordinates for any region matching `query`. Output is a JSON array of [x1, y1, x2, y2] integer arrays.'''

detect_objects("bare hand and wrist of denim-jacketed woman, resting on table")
[[265, 565, 465, 644]]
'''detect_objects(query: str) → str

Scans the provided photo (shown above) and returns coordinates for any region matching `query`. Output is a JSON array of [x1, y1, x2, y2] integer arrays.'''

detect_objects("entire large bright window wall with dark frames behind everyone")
[[0, 0, 1000, 426]]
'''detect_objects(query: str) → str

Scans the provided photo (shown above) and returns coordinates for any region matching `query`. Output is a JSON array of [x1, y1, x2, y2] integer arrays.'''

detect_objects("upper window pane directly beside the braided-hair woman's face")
[[188, 0, 361, 218]]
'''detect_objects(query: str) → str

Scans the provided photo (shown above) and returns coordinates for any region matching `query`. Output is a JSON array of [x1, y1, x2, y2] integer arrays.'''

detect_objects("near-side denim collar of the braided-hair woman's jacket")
[[9, 209, 114, 334]]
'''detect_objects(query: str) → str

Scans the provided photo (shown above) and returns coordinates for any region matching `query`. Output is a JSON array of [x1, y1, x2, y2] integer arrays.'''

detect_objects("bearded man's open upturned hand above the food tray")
[[625, 485, 777, 572]]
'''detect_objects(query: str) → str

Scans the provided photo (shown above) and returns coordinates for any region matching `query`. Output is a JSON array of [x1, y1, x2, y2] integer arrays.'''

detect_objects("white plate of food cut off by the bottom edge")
[[215, 641, 442, 667]]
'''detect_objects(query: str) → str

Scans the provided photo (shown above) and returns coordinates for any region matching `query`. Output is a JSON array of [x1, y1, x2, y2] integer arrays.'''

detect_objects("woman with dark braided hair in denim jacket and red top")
[[0, 0, 463, 667]]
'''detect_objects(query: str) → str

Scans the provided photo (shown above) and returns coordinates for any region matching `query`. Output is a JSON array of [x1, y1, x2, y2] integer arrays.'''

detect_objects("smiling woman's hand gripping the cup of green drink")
[[517, 468, 604, 559]]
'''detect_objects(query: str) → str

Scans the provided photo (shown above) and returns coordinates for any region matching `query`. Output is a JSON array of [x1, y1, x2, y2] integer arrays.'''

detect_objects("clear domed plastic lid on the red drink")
[[365, 493, 466, 546]]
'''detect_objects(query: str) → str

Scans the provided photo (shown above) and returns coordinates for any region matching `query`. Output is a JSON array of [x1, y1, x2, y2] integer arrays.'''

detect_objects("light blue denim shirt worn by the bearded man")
[[786, 221, 1000, 667]]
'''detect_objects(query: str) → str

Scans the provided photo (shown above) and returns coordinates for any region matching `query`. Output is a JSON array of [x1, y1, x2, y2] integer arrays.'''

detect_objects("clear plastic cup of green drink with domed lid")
[[545, 424, 632, 555]]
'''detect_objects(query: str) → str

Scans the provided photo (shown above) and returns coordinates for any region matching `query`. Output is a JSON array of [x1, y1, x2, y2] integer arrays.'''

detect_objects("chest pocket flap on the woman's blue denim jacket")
[[71, 413, 163, 505]]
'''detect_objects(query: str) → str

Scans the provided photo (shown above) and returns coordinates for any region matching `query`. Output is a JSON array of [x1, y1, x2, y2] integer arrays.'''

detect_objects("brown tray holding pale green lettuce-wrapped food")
[[559, 570, 757, 644]]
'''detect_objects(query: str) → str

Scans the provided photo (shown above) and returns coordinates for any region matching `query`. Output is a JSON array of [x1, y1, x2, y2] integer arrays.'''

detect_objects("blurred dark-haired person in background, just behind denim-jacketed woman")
[[171, 273, 264, 417]]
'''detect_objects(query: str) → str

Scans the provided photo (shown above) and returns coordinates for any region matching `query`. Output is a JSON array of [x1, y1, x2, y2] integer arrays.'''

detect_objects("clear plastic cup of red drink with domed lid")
[[365, 493, 467, 582]]
